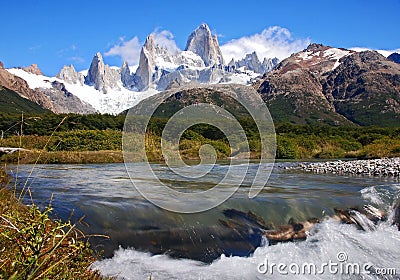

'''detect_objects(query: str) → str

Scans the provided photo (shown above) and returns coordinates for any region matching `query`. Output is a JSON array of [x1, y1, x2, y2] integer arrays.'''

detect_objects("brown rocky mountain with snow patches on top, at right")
[[255, 44, 400, 125]]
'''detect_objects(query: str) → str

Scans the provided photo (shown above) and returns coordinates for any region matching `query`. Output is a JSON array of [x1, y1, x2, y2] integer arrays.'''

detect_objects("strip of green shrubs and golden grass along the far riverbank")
[[0, 129, 400, 164]]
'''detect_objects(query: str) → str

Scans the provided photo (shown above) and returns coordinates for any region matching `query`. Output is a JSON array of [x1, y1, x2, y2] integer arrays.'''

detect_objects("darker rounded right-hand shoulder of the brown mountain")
[[321, 51, 400, 125]]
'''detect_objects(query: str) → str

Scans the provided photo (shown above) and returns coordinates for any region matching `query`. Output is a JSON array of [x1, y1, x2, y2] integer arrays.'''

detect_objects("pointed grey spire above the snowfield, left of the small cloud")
[[85, 52, 120, 93]]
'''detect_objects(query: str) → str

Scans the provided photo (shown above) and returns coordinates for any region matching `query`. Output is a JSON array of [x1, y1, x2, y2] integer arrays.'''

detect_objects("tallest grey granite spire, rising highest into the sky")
[[185, 23, 225, 66]]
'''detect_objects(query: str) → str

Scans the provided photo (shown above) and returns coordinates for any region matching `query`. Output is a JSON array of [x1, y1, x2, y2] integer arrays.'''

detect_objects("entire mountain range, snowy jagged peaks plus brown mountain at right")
[[0, 24, 400, 126]]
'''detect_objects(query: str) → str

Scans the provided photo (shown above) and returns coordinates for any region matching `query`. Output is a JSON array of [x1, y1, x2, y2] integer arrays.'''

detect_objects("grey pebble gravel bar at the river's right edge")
[[295, 158, 400, 178]]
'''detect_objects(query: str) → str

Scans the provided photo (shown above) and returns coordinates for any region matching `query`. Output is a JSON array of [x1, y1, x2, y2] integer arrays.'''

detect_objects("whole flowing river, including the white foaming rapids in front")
[[8, 162, 400, 279]]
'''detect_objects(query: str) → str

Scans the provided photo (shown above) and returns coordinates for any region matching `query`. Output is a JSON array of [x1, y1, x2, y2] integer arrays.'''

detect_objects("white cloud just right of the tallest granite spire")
[[221, 26, 310, 62]]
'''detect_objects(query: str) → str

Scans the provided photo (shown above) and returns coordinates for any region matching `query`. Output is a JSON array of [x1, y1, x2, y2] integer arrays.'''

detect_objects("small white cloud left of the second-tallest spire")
[[104, 36, 142, 65]]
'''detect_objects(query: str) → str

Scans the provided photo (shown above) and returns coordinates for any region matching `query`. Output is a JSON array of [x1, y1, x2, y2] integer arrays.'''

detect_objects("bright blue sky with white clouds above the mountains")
[[0, 0, 400, 75]]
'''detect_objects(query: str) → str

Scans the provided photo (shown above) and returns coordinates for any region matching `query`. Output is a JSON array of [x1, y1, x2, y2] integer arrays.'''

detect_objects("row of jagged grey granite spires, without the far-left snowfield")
[[57, 24, 278, 93]]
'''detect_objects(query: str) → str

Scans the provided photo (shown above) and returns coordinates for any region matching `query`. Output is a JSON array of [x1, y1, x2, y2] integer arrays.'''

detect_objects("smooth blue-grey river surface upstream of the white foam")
[[8, 163, 398, 262]]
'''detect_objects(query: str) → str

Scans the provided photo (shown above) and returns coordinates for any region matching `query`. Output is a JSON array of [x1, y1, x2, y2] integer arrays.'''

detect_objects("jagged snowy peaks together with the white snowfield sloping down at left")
[[8, 24, 278, 114]]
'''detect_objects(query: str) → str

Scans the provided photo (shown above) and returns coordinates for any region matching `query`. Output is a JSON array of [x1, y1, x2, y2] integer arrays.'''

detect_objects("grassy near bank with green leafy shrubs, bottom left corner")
[[0, 169, 101, 279]]
